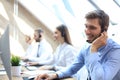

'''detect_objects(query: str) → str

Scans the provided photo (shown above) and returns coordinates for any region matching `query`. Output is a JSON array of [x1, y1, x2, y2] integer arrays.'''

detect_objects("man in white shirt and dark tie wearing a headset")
[[21, 29, 53, 65]]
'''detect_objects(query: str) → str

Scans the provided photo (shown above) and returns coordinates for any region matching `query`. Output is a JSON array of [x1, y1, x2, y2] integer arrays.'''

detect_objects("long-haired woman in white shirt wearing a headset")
[[39, 25, 77, 70]]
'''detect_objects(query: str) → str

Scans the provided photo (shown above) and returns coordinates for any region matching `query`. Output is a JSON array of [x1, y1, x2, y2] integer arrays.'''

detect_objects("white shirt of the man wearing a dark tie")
[[28, 39, 53, 65]]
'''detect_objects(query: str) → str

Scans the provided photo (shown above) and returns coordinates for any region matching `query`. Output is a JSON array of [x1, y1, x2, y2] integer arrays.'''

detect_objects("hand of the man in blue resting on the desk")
[[34, 73, 57, 80]]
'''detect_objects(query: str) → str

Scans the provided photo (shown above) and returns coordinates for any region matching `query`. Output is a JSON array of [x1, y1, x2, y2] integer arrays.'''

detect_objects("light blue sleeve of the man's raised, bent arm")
[[86, 49, 120, 80]]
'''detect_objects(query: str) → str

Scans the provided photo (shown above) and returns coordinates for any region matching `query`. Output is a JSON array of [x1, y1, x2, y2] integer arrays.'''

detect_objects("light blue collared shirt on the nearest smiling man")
[[56, 39, 120, 80]]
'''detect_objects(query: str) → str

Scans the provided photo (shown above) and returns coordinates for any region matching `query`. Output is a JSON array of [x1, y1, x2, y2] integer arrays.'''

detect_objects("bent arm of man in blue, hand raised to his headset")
[[86, 32, 120, 80]]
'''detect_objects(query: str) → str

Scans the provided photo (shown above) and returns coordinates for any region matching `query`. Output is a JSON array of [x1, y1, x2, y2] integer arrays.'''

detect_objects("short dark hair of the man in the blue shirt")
[[85, 10, 109, 32]]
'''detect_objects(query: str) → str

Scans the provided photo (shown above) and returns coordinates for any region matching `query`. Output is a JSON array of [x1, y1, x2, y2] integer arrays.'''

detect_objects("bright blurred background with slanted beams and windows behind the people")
[[0, 0, 120, 56]]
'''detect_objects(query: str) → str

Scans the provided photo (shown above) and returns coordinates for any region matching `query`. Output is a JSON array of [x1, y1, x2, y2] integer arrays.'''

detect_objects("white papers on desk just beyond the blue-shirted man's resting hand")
[[22, 70, 55, 76]]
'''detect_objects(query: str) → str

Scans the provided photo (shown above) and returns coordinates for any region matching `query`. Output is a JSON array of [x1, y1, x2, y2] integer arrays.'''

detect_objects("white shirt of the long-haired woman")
[[54, 43, 77, 70]]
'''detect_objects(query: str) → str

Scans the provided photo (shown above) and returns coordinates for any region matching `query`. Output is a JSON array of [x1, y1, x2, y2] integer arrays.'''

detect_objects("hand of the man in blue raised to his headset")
[[91, 32, 108, 53]]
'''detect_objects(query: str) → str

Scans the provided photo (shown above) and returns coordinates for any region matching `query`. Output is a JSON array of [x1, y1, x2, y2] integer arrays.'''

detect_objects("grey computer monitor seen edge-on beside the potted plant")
[[0, 25, 12, 80]]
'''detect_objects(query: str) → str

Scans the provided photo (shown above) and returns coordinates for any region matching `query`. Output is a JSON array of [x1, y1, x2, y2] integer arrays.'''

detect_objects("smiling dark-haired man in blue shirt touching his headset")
[[35, 10, 120, 80]]
